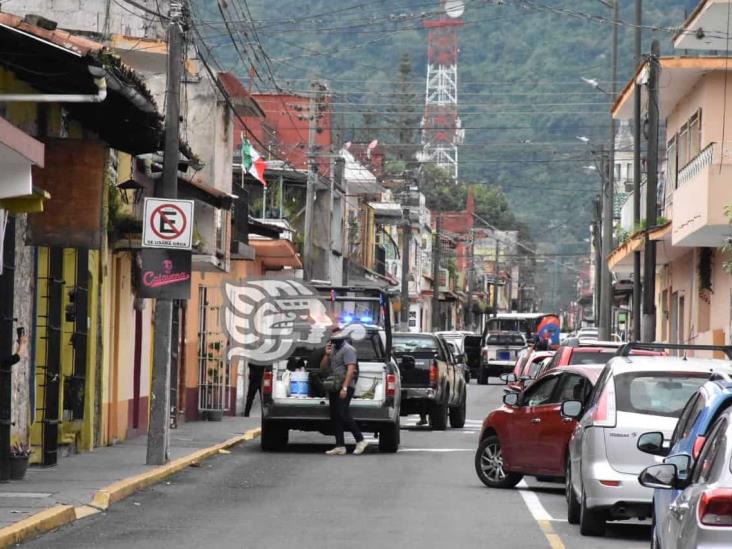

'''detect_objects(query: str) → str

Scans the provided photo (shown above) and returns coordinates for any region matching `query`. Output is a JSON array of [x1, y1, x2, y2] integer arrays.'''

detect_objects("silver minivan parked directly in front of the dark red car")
[[563, 355, 731, 536]]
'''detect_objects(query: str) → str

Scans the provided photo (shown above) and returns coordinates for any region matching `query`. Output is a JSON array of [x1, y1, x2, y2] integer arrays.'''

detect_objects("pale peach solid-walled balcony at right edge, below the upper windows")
[[671, 142, 732, 247]]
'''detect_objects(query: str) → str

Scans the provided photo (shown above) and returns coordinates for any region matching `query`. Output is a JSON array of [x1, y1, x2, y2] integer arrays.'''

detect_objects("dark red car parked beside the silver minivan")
[[475, 364, 603, 488]]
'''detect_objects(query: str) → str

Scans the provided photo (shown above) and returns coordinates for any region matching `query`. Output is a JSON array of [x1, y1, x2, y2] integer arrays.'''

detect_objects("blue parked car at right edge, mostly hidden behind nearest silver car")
[[637, 373, 732, 546]]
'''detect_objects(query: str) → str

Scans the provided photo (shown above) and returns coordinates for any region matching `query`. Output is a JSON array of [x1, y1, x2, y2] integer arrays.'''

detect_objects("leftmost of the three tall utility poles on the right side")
[[600, 0, 619, 341]]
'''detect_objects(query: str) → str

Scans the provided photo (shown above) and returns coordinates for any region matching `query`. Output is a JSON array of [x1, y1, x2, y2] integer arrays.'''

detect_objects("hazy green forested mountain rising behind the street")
[[196, 0, 696, 308]]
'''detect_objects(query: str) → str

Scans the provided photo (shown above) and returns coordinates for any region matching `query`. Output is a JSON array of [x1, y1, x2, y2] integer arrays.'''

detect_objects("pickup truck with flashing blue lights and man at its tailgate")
[[261, 287, 401, 453]]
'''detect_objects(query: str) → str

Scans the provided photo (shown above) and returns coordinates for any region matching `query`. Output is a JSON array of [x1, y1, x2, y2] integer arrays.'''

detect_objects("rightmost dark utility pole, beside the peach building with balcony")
[[641, 40, 660, 342]]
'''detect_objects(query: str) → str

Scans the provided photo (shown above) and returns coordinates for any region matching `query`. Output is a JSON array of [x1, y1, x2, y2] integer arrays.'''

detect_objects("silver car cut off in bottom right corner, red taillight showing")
[[638, 409, 732, 549]]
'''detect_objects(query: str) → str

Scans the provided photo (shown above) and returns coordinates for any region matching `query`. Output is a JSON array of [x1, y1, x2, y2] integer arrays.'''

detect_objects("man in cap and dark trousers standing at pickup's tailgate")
[[320, 328, 368, 456]]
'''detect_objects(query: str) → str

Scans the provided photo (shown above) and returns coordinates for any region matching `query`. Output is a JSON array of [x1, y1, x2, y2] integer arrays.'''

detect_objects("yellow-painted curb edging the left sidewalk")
[[0, 428, 262, 548]]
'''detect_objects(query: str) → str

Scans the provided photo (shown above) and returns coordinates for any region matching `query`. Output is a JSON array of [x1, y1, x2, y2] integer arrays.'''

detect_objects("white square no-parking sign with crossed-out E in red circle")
[[142, 198, 193, 250]]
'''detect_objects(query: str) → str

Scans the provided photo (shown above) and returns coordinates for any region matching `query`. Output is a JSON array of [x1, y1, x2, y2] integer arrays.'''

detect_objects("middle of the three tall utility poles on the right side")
[[632, 0, 643, 341]]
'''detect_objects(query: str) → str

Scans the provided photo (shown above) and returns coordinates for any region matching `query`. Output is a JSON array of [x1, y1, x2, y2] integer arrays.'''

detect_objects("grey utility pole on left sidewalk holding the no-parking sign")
[[146, 0, 183, 465]]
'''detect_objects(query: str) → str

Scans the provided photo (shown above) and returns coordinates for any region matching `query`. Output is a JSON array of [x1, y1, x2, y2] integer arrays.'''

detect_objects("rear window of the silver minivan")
[[615, 372, 709, 418]]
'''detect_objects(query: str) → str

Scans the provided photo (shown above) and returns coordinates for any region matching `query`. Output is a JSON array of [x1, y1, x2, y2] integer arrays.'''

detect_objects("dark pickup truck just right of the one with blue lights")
[[394, 333, 467, 431]]
